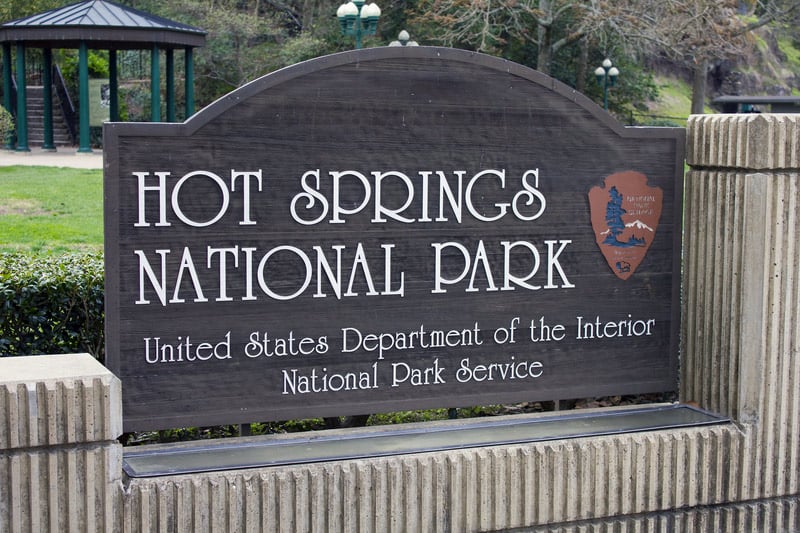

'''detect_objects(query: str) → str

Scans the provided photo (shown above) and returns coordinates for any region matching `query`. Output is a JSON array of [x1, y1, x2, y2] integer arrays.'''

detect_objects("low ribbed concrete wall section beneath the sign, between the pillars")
[[123, 424, 746, 532]]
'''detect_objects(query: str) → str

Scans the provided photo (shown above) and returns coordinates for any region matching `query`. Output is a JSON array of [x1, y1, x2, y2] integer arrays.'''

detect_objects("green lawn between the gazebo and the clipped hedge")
[[0, 166, 103, 253]]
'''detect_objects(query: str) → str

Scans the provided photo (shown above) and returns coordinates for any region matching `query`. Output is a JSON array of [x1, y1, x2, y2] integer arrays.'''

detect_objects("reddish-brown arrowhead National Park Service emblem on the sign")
[[589, 171, 664, 280]]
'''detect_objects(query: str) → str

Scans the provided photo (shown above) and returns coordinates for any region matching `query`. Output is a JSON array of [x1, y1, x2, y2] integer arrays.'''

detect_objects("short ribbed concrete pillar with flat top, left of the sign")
[[0, 354, 122, 533]]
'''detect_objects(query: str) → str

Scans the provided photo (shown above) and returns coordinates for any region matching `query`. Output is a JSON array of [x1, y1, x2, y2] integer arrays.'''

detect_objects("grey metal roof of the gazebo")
[[0, 0, 206, 50]]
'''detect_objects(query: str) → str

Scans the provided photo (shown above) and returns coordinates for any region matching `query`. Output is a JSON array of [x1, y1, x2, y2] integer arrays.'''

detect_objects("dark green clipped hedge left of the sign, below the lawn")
[[0, 253, 104, 362]]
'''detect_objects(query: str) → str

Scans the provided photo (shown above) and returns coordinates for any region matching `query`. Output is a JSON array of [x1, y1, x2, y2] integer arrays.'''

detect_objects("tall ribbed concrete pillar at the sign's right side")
[[680, 114, 800, 500]]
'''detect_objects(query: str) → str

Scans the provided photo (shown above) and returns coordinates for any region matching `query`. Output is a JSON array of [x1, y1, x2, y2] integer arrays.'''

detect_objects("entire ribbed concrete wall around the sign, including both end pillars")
[[0, 115, 800, 532]]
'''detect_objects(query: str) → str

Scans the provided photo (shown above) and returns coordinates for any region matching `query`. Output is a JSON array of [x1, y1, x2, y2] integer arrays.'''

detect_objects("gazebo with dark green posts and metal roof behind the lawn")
[[0, 0, 206, 152]]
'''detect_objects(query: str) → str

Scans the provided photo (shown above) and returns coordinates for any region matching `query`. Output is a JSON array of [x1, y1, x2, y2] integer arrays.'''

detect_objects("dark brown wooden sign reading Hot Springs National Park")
[[104, 47, 684, 430]]
